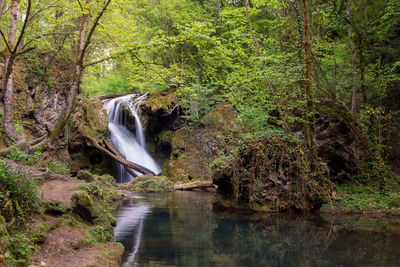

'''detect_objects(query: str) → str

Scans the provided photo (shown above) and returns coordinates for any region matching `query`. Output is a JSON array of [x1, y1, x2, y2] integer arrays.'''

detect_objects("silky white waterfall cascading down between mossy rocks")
[[103, 94, 161, 183]]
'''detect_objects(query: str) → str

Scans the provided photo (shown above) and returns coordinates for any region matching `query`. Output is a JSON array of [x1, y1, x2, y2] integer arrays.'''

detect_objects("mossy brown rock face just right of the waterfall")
[[163, 103, 243, 182]]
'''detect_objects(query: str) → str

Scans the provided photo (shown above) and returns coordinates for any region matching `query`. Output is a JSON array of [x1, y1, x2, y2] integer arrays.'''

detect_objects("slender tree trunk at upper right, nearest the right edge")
[[347, 0, 358, 116]]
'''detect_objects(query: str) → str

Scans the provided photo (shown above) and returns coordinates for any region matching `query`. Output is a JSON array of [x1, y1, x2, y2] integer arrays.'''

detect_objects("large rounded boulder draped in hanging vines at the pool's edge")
[[213, 132, 330, 212]]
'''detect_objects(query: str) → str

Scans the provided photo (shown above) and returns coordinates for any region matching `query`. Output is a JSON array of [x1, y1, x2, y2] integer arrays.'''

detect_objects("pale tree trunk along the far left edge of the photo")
[[3, 0, 23, 142]]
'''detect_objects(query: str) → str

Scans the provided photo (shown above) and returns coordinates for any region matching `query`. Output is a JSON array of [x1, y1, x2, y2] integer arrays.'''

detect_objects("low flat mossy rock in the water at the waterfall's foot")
[[120, 174, 174, 192]]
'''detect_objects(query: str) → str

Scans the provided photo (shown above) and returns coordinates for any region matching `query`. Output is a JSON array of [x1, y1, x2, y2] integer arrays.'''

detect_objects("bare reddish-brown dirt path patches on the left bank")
[[31, 176, 123, 267]]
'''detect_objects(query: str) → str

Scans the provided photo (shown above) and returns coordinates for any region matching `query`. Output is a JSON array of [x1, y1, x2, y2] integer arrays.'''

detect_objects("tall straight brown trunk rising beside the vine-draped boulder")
[[303, 0, 318, 163]]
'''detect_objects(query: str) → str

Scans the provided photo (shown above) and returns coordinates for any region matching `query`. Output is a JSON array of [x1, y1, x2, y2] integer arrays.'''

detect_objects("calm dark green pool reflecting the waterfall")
[[114, 192, 400, 267]]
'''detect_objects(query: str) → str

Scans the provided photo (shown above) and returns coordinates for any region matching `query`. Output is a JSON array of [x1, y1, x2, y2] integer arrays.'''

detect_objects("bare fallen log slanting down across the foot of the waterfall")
[[86, 136, 156, 176]]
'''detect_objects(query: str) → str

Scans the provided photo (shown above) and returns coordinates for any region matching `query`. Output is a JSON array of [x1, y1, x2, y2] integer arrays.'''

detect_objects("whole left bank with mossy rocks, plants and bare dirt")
[[0, 160, 123, 266]]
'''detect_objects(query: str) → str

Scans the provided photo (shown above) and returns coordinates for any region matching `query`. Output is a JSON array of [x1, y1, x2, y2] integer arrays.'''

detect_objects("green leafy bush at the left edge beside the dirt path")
[[0, 162, 39, 224]]
